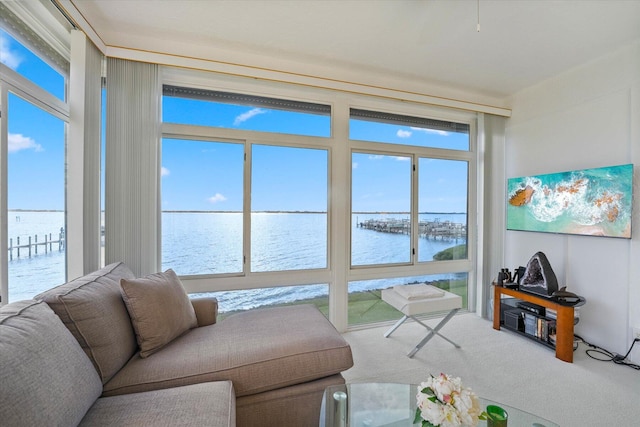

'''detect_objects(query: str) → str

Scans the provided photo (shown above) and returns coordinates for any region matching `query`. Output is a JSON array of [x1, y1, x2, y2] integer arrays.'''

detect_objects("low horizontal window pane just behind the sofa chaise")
[[190, 284, 329, 319]]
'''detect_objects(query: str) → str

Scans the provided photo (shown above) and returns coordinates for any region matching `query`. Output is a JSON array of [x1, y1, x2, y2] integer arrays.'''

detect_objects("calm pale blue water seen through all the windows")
[[8, 212, 466, 311]]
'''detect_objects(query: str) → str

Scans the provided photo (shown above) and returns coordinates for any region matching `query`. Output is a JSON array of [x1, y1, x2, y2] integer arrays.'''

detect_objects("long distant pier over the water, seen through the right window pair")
[[357, 219, 467, 240]]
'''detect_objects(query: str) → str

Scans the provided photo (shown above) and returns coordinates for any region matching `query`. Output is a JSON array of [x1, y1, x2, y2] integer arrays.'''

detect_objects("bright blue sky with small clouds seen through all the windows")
[[0, 32, 468, 212]]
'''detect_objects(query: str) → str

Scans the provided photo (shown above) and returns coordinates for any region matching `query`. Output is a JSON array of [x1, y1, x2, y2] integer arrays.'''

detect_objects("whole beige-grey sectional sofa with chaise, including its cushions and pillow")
[[0, 263, 353, 427]]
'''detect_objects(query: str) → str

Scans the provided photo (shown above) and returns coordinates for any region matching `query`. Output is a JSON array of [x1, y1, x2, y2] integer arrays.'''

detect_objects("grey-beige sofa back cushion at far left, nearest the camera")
[[0, 300, 102, 427]]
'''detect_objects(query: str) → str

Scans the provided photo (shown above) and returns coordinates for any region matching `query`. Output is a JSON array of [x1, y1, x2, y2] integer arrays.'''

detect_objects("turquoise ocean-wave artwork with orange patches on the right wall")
[[507, 164, 633, 239]]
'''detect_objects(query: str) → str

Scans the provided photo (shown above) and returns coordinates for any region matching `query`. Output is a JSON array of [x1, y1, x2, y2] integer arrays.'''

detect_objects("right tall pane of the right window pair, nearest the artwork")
[[418, 158, 468, 261]]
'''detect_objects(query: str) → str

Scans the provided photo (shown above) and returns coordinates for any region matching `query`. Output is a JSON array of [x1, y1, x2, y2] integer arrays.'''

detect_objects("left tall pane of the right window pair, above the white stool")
[[351, 153, 411, 266]]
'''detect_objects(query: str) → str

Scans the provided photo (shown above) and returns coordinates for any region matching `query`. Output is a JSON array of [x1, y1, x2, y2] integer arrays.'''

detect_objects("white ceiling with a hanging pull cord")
[[63, 0, 640, 99]]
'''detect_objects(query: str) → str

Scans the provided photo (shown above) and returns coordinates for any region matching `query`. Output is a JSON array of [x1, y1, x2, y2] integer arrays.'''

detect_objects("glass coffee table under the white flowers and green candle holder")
[[320, 383, 558, 427]]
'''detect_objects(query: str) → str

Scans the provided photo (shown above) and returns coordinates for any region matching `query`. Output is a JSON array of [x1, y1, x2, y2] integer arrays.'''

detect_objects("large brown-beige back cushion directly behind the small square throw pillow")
[[36, 262, 138, 383]]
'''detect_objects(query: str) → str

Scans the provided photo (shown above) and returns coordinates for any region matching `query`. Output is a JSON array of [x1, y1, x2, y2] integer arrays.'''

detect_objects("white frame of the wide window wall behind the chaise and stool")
[[161, 67, 480, 331]]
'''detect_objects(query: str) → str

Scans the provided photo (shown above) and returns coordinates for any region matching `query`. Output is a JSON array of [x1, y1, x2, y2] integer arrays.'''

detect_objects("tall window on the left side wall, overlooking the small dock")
[[0, 17, 68, 303]]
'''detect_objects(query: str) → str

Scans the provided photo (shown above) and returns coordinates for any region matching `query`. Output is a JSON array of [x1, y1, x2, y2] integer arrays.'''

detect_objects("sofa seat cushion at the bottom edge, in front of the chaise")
[[80, 381, 236, 427]]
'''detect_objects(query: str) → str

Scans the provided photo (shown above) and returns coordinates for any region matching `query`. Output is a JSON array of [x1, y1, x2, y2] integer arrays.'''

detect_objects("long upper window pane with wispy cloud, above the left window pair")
[[162, 86, 331, 137]]
